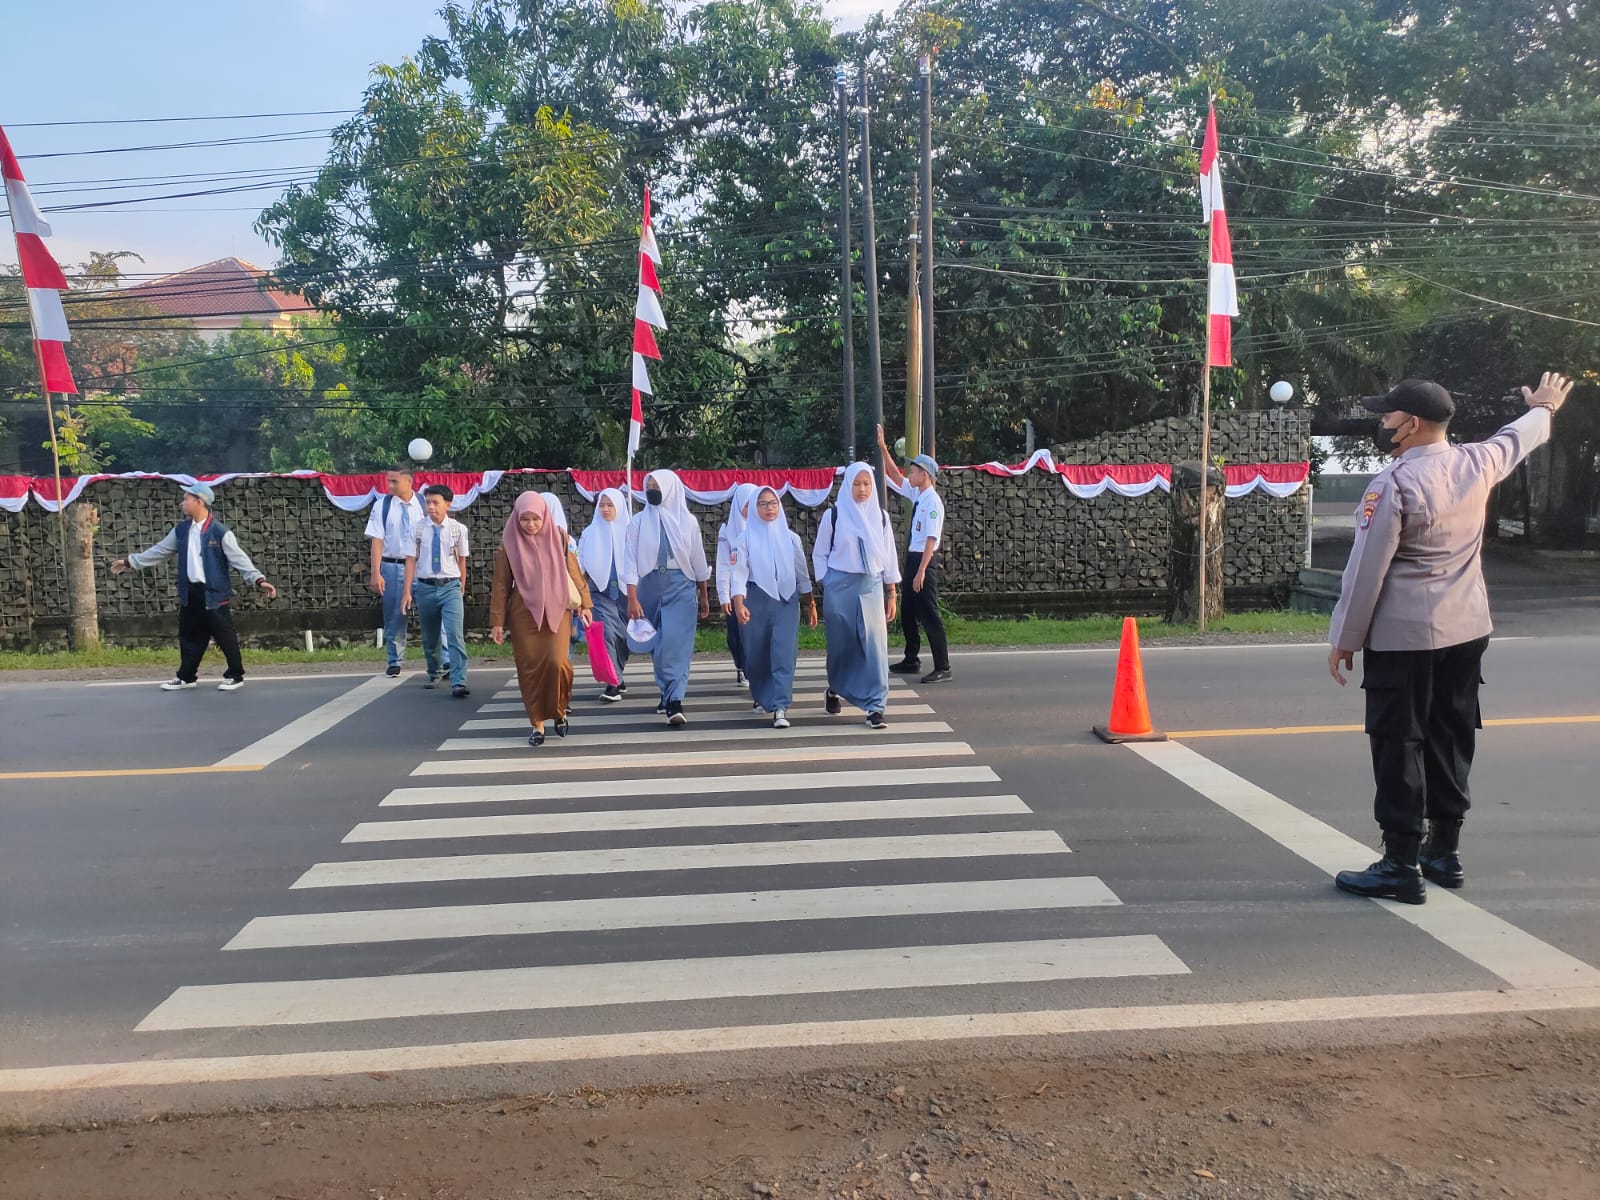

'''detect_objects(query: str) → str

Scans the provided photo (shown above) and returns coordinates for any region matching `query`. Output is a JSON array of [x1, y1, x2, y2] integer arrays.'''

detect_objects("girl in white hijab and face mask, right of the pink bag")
[[621, 470, 710, 728]]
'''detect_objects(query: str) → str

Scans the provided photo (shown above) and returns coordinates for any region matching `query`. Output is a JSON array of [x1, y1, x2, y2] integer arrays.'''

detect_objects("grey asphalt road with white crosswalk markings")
[[0, 637, 1600, 1114]]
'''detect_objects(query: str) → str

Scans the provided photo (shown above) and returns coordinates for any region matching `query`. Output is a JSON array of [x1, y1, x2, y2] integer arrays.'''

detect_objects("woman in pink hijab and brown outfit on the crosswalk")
[[490, 491, 592, 746]]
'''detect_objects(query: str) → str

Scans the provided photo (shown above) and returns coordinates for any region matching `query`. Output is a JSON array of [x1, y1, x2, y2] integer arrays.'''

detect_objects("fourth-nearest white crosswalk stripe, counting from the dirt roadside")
[[344, 795, 1032, 843]]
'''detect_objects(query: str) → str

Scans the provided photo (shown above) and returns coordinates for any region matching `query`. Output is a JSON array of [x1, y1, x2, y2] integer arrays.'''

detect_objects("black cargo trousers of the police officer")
[[1362, 637, 1490, 834]]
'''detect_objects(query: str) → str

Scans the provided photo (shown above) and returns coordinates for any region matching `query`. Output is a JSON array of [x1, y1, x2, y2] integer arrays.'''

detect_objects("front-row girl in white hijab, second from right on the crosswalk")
[[730, 488, 816, 730]]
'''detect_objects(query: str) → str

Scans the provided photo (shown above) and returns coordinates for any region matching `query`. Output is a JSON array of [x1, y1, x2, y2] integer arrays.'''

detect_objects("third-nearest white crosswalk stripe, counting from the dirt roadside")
[[290, 829, 1070, 888]]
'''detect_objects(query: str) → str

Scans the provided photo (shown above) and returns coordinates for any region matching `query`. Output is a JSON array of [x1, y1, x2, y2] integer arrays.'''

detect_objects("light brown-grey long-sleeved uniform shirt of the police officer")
[[1328, 408, 1550, 653]]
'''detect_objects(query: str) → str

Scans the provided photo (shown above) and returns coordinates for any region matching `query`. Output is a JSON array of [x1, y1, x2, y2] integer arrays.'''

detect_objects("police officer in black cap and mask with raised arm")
[[1328, 371, 1573, 904]]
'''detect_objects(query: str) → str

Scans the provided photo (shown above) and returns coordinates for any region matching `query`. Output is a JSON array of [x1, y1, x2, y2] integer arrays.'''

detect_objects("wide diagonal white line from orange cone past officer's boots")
[[1128, 742, 1600, 987]]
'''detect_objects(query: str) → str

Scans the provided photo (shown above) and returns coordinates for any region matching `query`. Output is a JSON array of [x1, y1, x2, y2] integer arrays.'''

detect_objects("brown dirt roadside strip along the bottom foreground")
[[0, 1018, 1600, 1200]]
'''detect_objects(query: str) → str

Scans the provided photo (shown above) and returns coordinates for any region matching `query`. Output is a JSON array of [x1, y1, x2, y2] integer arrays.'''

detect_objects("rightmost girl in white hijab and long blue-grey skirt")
[[811, 462, 901, 730]]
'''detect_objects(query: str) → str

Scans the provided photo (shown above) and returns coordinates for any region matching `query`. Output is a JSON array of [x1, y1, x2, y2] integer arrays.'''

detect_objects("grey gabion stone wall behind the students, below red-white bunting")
[[0, 413, 1307, 646]]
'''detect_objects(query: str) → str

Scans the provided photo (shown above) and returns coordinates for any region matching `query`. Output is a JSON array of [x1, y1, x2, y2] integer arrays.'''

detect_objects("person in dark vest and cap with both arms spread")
[[110, 483, 278, 691]]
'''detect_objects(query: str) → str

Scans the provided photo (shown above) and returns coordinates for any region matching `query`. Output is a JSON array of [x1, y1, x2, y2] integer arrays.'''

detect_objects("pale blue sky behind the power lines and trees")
[[0, 0, 888, 278]]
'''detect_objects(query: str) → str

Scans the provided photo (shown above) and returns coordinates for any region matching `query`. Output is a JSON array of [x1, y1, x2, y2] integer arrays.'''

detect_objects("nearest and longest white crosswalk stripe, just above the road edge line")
[[138, 934, 1189, 1032]]
